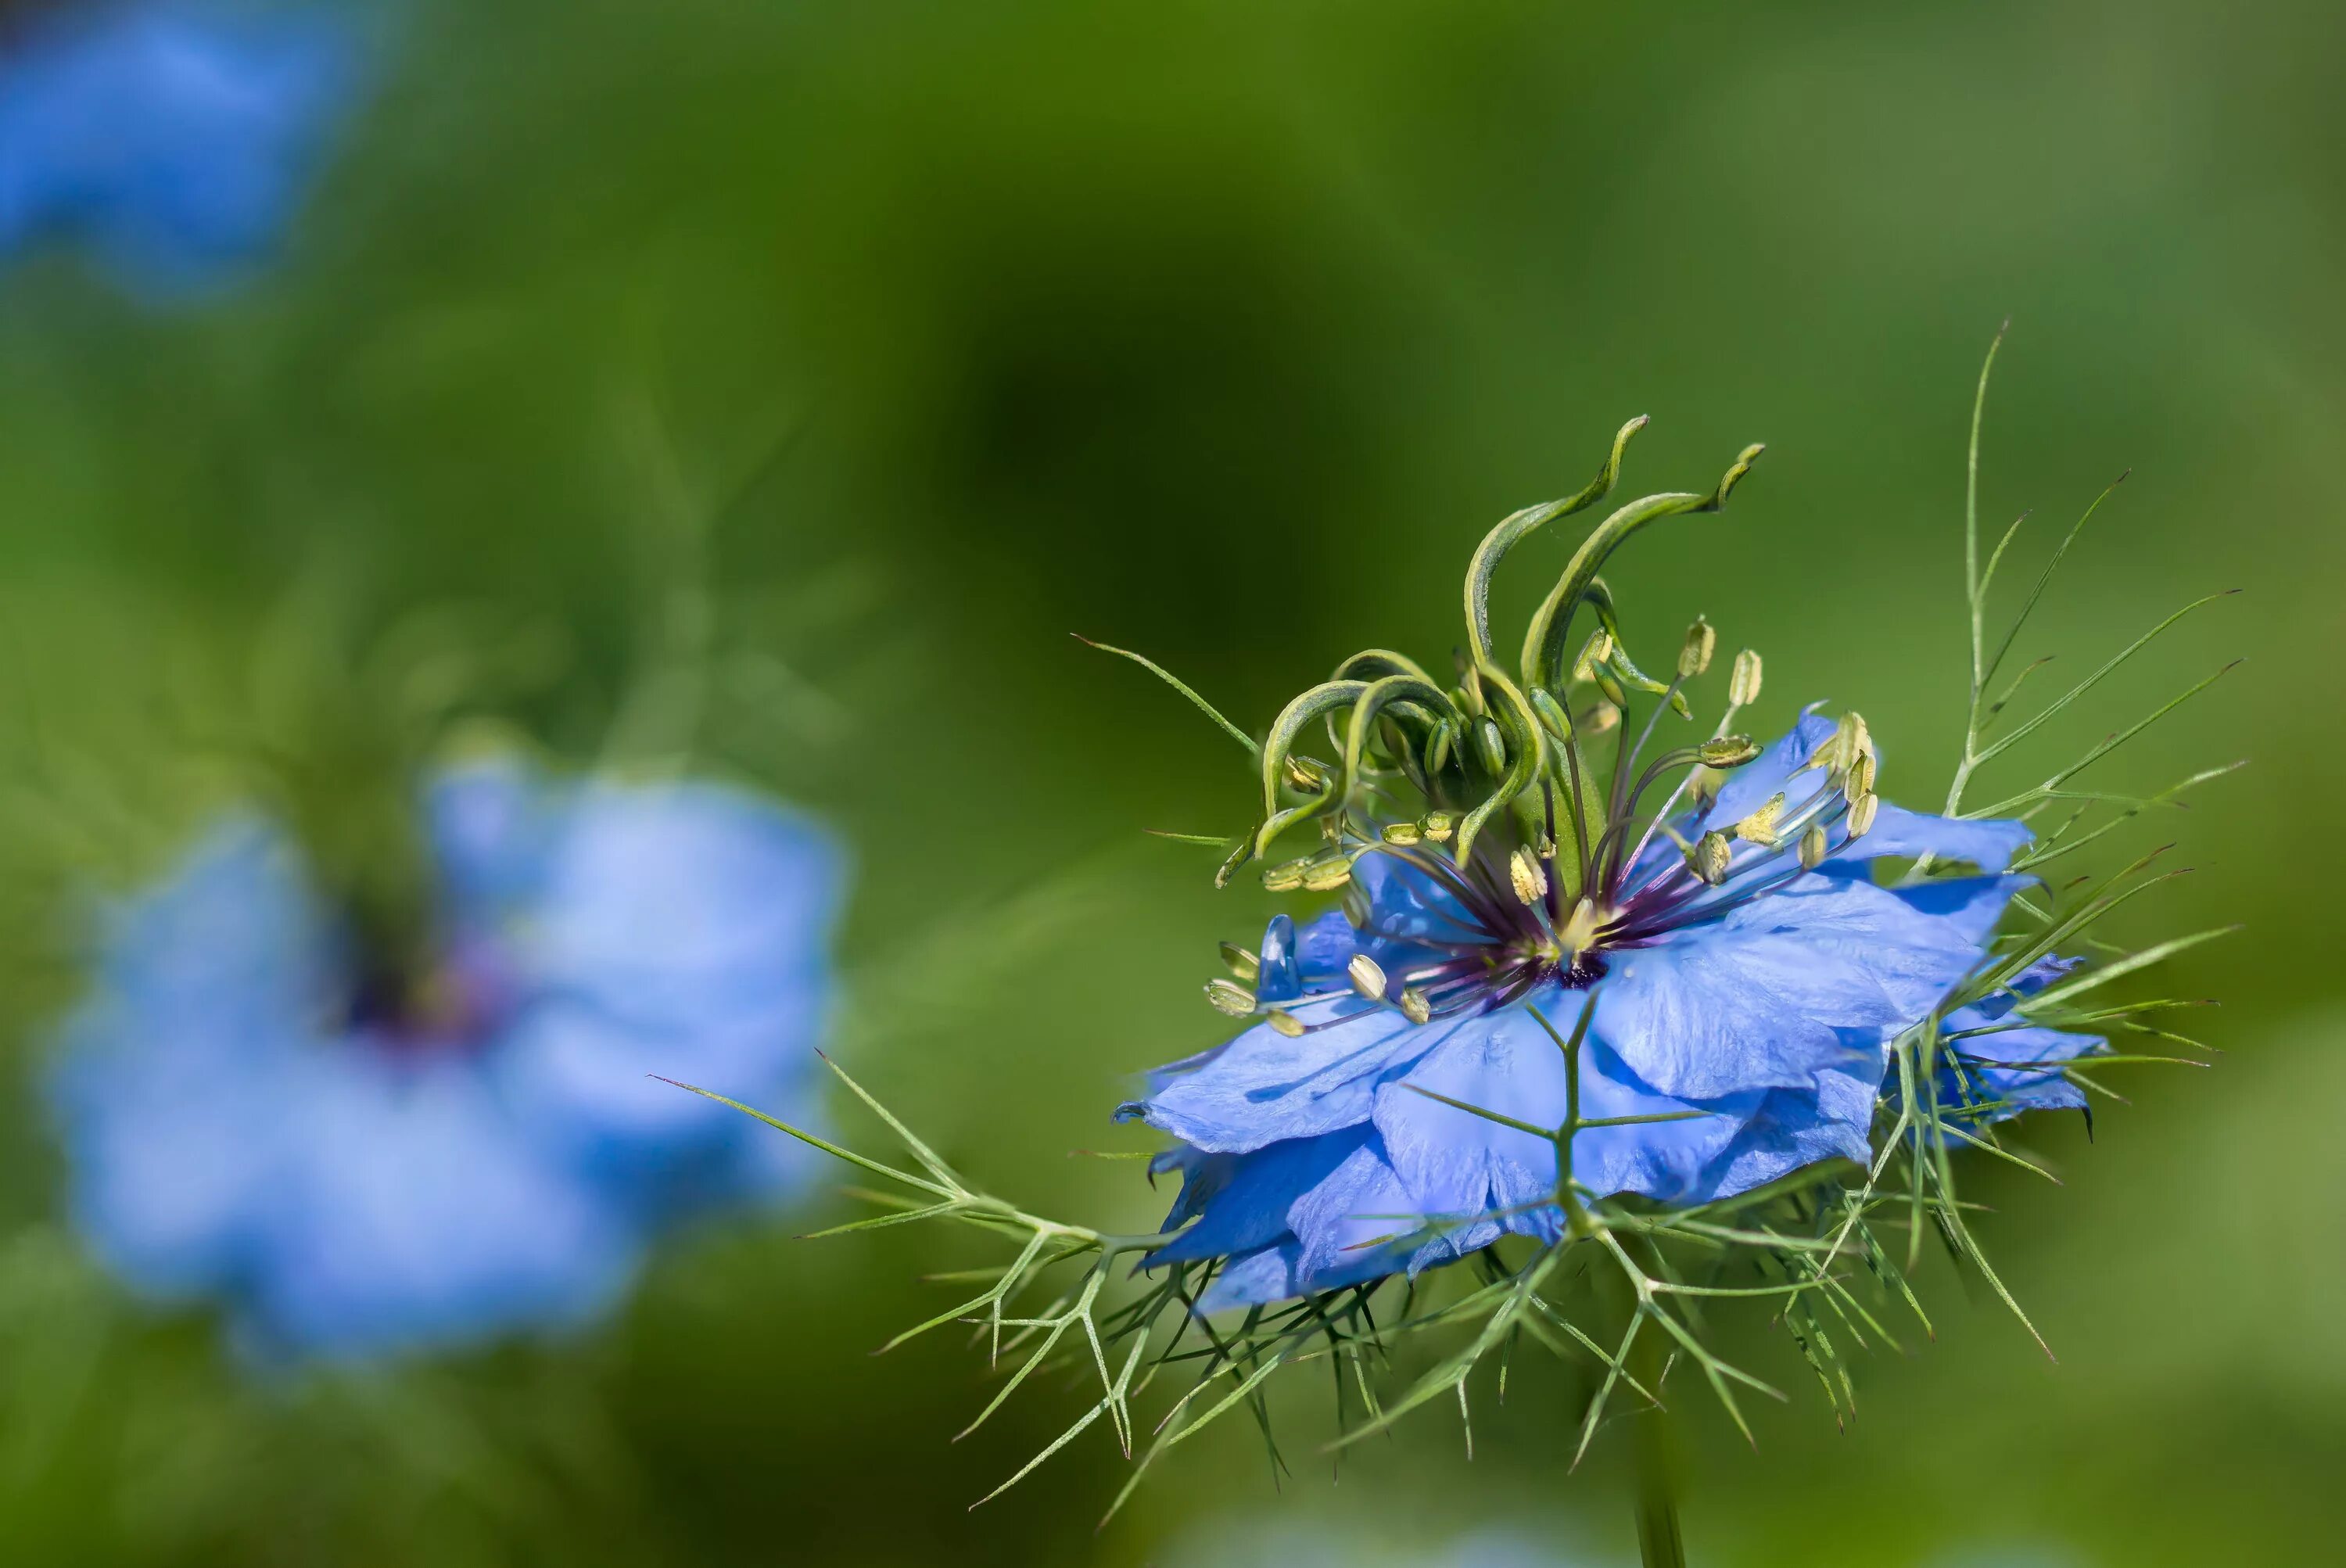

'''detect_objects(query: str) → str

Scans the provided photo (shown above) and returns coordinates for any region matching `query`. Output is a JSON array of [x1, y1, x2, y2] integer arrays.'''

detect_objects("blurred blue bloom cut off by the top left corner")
[[0, 0, 359, 298]]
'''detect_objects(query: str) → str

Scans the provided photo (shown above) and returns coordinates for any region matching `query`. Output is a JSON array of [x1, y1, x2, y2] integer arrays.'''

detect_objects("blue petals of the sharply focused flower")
[[1119, 711, 2067, 1310]]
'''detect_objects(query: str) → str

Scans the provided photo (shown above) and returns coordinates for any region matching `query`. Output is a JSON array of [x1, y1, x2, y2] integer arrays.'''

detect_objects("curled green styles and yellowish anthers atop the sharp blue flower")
[[1206, 418, 1879, 1035]]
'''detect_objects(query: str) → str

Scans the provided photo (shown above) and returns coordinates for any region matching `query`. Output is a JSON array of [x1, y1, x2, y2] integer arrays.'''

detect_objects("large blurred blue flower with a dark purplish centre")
[[54, 762, 842, 1357]]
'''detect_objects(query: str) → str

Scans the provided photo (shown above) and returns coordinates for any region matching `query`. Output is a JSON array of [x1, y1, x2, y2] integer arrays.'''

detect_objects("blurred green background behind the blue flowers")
[[0, 0, 2346, 1566]]
